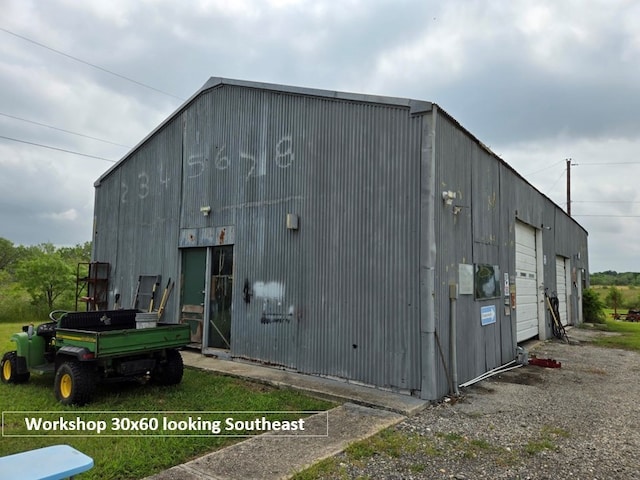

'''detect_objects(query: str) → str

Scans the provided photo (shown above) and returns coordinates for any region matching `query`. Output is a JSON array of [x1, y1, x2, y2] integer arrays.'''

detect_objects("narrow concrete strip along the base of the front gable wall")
[[182, 351, 427, 416]]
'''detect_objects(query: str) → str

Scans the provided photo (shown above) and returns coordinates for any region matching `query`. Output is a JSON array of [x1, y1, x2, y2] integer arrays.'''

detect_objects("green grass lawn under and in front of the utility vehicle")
[[0, 323, 334, 480]]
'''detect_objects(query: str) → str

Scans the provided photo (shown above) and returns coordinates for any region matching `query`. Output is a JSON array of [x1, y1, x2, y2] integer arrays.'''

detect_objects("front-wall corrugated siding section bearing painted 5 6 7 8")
[[174, 86, 420, 389]]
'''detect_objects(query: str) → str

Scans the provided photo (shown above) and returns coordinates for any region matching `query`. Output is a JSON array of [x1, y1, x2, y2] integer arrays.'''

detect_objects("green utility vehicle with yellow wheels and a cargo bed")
[[0, 309, 190, 405]]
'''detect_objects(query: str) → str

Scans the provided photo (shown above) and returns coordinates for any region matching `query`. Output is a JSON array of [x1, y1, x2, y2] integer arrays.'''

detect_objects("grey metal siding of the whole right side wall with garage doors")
[[436, 111, 587, 394]]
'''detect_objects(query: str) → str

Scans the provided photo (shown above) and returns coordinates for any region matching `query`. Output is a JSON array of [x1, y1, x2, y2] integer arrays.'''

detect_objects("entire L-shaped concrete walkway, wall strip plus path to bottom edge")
[[146, 351, 428, 480]]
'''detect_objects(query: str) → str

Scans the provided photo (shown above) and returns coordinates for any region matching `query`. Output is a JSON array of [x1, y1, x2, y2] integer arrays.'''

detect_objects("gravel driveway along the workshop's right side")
[[330, 328, 640, 480]]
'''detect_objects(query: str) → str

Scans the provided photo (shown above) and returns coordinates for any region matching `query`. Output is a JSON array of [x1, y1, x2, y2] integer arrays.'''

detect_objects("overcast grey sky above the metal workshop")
[[0, 0, 640, 272]]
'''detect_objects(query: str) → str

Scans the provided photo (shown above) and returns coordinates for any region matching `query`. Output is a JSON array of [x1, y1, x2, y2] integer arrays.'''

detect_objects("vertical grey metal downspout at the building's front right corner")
[[420, 104, 439, 400]]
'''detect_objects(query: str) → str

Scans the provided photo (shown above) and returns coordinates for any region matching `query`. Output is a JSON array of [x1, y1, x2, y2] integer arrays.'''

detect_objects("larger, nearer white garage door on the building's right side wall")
[[516, 222, 538, 342]]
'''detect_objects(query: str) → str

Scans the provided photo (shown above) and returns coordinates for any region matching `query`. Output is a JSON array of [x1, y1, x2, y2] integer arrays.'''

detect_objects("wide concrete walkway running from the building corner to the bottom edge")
[[148, 403, 405, 480]]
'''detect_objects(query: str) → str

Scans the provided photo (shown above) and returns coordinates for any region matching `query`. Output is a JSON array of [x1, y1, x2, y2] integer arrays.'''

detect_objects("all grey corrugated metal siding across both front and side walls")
[[94, 79, 587, 400]]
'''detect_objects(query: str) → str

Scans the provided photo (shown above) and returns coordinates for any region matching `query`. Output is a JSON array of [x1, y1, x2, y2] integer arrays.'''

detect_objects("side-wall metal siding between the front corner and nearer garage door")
[[436, 115, 512, 394]]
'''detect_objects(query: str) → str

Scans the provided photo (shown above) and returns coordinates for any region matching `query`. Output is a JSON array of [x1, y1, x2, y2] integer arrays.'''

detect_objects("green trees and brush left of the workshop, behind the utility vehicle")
[[0, 237, 91, 321]]
